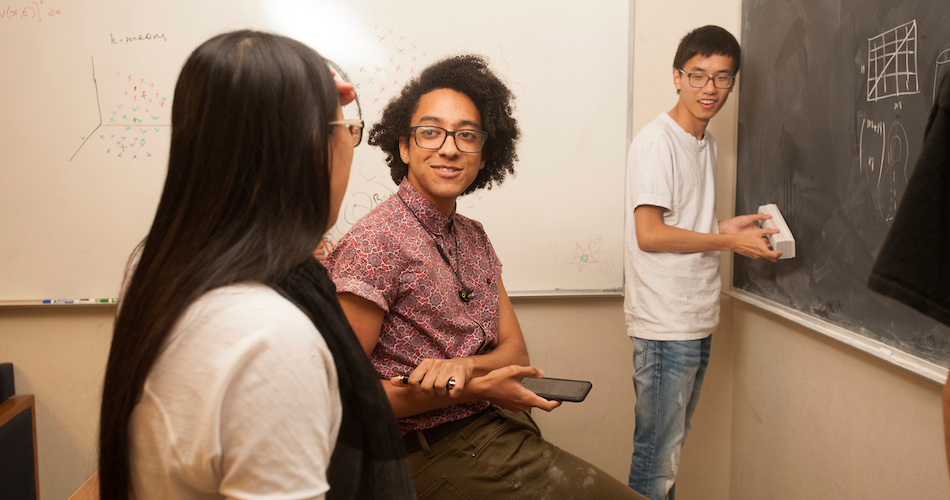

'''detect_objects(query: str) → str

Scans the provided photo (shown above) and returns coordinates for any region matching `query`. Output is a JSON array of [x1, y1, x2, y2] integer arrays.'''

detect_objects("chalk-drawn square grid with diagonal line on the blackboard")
[[867, 20, 920, 101]]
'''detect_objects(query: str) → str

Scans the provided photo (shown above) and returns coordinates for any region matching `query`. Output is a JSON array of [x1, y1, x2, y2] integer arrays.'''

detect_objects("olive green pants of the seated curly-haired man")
[[409, 406, 646, 500]]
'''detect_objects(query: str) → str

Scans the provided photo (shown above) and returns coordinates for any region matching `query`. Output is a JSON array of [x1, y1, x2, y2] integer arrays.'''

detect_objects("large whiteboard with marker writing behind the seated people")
[[0, 0, 632, 304]]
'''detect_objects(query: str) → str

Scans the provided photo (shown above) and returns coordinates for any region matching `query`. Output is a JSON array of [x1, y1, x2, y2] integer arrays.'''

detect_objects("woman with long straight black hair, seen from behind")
[[99, 31, 414, 500]]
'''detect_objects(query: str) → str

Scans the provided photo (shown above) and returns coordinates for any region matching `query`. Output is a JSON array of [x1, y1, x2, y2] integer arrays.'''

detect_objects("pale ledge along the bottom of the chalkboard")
[[723, 288, 950, 385]]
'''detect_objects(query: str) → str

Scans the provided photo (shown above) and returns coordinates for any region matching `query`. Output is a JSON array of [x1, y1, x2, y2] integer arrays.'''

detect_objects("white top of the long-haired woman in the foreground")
[[129, 283, 343, 500]]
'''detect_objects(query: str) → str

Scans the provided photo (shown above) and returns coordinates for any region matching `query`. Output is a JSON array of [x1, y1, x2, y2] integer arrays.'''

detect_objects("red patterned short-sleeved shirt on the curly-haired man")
[[327, 180, 501, 433]]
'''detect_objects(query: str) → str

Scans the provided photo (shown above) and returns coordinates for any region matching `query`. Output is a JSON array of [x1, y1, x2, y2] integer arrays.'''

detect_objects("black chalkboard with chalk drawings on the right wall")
[[733, 0, 950, 366]]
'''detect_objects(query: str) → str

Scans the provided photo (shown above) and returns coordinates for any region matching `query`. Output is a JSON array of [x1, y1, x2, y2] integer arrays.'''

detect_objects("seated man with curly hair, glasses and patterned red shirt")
[[327, 55, 643, 499]]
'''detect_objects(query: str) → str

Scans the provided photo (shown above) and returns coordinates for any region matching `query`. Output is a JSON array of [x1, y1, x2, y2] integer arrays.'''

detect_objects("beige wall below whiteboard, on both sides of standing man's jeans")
[[514, 298, 732, 499]]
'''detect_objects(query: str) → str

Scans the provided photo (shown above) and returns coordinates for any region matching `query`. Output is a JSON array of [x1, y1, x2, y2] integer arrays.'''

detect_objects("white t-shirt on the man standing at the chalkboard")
[[624, 113, 721, 340]]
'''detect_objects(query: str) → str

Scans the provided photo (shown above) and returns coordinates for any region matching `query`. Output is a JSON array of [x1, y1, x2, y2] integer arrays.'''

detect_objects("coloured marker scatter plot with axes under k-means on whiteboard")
[[69, 60, 171, 161]]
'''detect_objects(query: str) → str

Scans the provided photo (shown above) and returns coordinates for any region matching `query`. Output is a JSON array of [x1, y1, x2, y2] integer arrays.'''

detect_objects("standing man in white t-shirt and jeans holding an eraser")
[[624, 26, 781, 500]]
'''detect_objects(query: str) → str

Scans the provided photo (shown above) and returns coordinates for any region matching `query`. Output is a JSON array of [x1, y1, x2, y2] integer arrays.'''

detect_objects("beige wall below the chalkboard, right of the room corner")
[[729, 301, 950, 499]]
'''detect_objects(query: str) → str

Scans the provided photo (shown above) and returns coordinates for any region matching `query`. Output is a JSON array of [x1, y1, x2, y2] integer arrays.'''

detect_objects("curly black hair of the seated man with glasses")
[[367, 54, 521, 194]]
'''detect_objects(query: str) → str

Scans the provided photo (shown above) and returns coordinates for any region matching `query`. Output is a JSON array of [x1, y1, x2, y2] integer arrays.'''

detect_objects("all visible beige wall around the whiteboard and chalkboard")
[[0, 0, 950, 500]]
